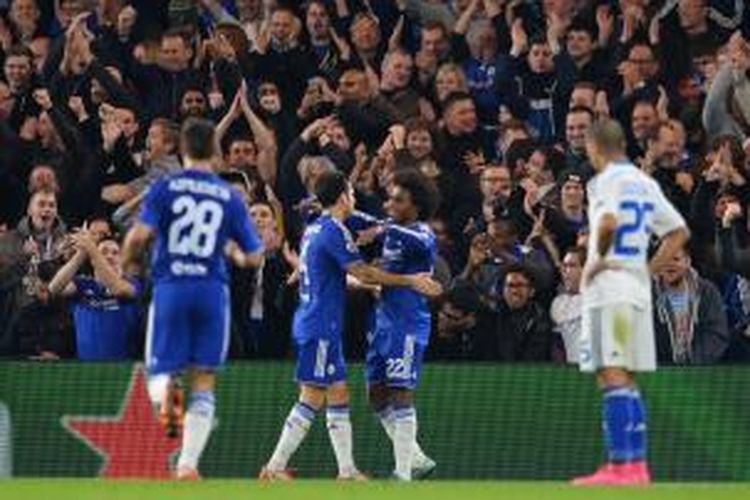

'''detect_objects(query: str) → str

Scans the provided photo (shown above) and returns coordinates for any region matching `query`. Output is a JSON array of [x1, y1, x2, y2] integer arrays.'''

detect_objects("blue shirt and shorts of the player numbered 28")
[[140, 170, 260, 374]]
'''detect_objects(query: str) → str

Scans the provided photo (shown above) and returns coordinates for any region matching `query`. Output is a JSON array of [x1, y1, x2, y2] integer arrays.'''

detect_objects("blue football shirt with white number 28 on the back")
[[140, 170, 261, 285]]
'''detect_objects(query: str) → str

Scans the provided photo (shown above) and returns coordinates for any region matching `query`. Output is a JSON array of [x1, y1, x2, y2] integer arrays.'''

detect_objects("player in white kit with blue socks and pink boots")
[[573, 120, 688, 485]]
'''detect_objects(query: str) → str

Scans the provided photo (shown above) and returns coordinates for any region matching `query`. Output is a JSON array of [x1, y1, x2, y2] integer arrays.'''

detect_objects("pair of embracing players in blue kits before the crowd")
[[260, 172, 441, 480]]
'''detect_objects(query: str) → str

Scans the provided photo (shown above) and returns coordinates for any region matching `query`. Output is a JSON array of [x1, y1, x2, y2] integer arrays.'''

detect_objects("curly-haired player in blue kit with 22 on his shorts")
[[366, 170, 438, 481]]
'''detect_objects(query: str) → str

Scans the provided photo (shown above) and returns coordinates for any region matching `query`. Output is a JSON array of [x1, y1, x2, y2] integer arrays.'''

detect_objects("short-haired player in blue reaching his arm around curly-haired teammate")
[[260, 172, 442, 480]]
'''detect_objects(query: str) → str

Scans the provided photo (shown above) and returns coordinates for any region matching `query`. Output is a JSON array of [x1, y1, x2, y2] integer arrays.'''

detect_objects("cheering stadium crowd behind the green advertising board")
[[0, 0, 750, 364]]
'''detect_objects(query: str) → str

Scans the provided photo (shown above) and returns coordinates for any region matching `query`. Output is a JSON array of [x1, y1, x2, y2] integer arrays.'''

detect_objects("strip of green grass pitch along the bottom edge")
[[0, 479, 750, 500]]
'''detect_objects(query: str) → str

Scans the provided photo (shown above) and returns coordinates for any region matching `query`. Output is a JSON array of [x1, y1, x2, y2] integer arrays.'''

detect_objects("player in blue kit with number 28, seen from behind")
[[123, 119, 263, 479]]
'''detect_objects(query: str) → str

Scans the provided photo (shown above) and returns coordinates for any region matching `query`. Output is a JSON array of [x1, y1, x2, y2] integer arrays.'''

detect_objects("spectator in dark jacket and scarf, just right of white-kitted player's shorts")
[[654, 249, 730, 365]]
